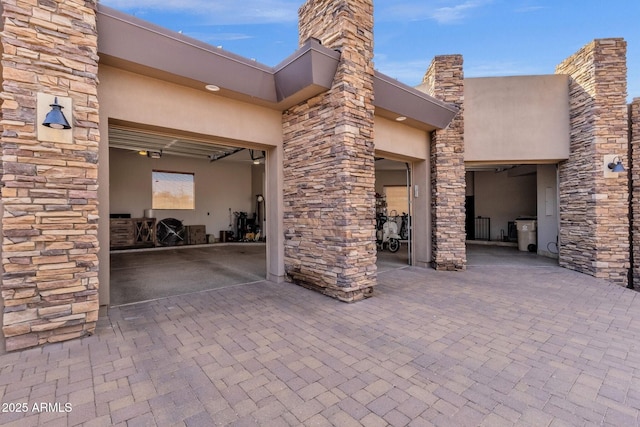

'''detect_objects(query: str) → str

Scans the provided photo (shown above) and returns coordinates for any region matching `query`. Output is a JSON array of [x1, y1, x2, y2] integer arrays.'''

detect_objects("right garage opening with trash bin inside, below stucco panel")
[[465, 164, 559, 266]]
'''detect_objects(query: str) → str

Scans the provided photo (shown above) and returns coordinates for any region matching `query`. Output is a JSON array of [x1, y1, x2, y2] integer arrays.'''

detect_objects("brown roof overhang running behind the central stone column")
[[97, 4, 458, 131]]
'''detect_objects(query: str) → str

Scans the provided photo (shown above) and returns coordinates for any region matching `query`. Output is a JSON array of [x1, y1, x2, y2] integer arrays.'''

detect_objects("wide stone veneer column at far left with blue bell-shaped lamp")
[[1, 0, 99, 350]]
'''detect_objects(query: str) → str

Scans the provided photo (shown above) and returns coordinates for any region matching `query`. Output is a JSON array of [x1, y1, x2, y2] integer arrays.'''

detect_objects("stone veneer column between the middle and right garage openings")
[[423, 55, 467, 270]]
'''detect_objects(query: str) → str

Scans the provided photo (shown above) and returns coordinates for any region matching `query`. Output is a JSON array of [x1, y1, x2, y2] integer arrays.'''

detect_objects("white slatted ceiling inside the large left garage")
[[109, 126, 249, 161]]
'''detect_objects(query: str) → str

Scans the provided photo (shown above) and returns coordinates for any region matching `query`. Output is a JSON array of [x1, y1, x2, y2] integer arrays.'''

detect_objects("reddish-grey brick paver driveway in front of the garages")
[[0, 266, 640, 427]]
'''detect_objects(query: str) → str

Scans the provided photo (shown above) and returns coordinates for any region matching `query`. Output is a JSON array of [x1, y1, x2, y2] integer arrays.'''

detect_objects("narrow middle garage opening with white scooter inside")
[[376, 158, 411, 271]]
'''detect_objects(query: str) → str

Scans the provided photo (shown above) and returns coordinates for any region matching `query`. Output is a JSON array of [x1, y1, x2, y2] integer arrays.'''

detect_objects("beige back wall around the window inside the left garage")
[[109, 149, 255, 237]]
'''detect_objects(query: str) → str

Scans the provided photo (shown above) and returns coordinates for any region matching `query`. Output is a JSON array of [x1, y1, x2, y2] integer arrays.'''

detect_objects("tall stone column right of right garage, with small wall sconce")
[[556, 39, 629, 285]]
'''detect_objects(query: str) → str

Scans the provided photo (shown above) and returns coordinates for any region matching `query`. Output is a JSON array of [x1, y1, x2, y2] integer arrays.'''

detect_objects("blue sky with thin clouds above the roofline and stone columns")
[[101, 0, 640, 100]]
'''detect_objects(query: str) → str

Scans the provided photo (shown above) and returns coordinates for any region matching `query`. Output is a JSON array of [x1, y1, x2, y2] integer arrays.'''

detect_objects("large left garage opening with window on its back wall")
[[109, 126, 268, 306]]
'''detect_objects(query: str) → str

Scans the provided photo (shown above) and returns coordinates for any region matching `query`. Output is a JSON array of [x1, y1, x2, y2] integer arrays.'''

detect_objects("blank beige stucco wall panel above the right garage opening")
[[464, 75, 569, 163]]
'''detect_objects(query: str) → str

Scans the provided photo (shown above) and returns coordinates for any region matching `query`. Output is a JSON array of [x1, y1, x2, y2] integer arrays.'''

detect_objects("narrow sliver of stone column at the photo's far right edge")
[[628, 98, 640, 289]]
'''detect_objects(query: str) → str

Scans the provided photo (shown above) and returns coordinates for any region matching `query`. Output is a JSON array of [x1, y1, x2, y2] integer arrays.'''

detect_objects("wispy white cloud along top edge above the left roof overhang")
[[101, 0, 300, 25]]
